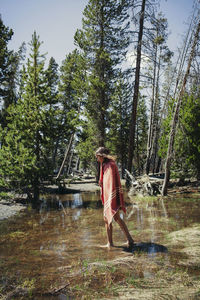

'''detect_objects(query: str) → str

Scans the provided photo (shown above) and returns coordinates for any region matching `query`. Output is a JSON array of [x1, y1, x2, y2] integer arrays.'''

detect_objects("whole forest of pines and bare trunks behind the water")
[[0, 0, 200, 202]]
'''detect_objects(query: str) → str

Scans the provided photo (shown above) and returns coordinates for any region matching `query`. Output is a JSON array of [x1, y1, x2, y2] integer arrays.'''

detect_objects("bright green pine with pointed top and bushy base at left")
[[0, 32, 51, 202]]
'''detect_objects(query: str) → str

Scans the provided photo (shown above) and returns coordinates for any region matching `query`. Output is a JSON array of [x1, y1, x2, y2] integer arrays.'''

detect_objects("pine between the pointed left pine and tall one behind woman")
[[57, 49, 85, 177]]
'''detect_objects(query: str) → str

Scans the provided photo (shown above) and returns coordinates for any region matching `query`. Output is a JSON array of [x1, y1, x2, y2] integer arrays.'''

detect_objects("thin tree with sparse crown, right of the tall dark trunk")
[[145, 15, 172, 175]]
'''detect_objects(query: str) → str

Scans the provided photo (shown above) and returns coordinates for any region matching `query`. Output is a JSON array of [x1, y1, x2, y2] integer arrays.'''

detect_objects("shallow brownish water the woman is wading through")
[[0, 192, 200, 300]]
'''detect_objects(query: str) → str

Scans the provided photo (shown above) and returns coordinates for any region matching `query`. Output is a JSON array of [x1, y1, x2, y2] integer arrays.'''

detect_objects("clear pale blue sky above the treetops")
[[0, 0, 193, 65]]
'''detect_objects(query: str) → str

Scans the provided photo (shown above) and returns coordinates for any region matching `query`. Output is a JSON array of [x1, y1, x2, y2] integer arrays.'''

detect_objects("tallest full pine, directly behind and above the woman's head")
[[75, 0, 129, 146]]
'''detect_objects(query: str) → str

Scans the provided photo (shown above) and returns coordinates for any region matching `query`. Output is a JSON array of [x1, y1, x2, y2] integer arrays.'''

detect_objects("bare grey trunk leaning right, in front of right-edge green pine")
[[162, 22, 200, 196]]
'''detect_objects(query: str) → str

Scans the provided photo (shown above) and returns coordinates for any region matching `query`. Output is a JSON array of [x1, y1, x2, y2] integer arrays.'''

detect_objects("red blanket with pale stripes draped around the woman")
[[100, 160, 126, 224]]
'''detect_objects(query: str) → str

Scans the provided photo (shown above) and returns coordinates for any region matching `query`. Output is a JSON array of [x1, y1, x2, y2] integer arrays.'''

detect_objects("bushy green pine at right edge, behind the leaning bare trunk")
[[160, 91, 200, 181]]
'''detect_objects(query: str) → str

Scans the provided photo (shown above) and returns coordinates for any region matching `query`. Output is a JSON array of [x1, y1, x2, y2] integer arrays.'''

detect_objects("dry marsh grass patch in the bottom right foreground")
[[63, 246, 200, 300]]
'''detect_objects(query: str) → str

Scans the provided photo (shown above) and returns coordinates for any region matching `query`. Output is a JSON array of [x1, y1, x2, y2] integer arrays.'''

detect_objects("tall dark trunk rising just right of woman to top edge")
[[128, 0, 146, 172]]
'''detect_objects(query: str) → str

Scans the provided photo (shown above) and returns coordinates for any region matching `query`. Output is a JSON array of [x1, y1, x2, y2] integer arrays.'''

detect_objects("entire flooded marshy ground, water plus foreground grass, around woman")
[[0, 192, 200, 300]]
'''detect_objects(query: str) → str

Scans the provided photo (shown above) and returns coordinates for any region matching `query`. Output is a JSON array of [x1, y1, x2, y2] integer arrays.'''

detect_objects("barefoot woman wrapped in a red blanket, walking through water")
[[95, 147, 134, 248]]
